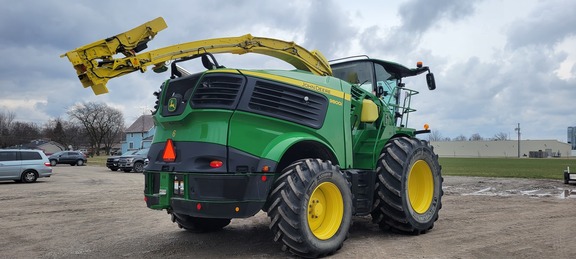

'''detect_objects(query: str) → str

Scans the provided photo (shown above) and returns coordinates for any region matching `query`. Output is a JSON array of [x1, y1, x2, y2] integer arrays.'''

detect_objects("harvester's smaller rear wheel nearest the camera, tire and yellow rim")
[[268, 159, 352, 258]]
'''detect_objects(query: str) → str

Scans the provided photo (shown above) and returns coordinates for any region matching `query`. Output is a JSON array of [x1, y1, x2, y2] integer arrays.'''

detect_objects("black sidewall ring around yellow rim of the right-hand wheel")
[[402, 144, 442, 229]]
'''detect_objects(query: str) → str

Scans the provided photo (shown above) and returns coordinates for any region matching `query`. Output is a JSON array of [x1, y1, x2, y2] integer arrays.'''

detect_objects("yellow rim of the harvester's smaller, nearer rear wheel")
[[306, 182, 344, 240]]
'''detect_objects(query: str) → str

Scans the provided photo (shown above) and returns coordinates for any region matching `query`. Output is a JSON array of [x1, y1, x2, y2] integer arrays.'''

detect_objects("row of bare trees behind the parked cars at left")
[[0, 102, 124, 155]]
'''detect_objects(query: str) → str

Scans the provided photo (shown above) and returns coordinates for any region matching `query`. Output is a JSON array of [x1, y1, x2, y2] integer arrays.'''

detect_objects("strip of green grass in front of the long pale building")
[[440, 157, 576, 179]]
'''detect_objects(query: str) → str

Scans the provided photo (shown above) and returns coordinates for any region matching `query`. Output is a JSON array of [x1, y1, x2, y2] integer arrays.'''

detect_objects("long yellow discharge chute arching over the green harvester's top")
[[61, 17, 332, 95]]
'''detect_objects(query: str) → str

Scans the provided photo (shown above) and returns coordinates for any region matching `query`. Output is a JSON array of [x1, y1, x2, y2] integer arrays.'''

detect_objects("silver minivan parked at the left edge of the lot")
[[0, 149, 52, 183]]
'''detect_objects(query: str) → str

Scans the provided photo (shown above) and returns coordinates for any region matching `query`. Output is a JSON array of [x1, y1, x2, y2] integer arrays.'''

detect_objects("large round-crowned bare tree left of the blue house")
[[68, 102, 124, 155]]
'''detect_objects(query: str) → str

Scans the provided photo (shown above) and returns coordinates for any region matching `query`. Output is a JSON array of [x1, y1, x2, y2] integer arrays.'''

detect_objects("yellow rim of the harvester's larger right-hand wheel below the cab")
[[408, 160, 434, 214]]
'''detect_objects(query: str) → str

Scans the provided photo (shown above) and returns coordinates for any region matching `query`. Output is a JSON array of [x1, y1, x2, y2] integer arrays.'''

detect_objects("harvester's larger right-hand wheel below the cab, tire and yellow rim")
[[372, 137, 443, 235]]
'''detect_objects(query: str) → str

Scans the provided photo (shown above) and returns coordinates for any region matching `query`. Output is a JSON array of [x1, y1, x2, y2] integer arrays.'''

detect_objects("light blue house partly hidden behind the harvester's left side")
[[122, 115, 156, 153]]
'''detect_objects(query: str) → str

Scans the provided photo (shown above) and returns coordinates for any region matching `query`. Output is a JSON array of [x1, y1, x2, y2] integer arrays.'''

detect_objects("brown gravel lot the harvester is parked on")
[[0, 165, 576, 258]]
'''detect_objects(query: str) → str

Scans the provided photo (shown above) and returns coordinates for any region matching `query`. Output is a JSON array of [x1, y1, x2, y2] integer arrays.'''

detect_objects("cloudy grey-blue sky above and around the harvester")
[[0, 0, 576, 142]]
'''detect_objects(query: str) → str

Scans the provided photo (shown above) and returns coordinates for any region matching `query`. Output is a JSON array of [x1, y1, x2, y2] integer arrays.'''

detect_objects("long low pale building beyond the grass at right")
[[430, 140, 572, 158]]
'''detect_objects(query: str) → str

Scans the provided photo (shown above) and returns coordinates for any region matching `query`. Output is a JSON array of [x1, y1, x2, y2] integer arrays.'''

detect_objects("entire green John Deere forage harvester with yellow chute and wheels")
[[62, 18, 443, 257]]
